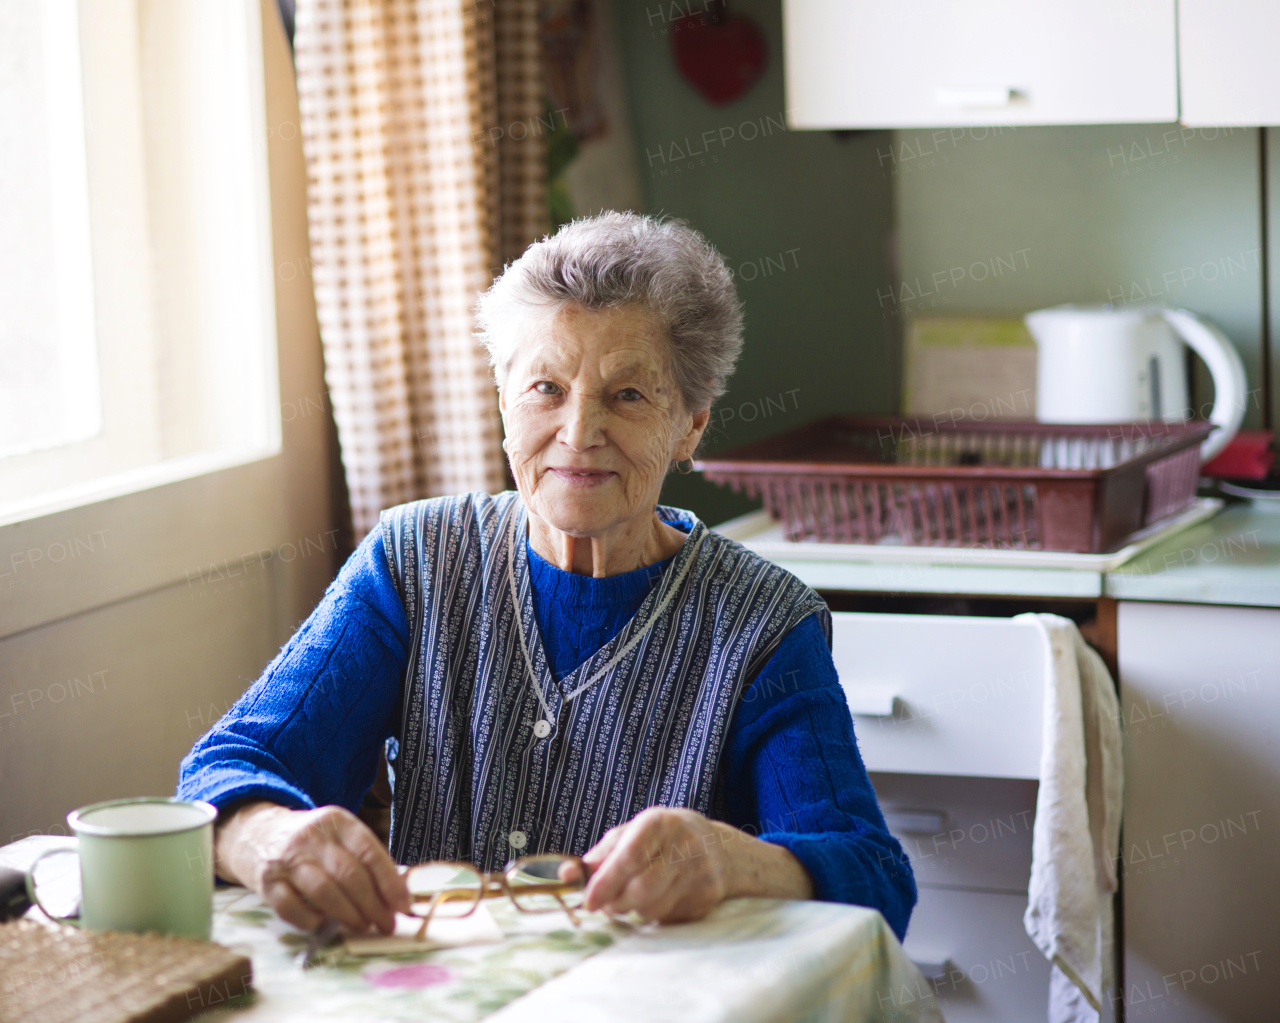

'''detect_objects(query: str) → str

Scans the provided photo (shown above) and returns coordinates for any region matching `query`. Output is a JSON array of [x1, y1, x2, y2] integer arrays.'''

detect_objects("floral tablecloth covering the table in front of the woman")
[[0, 836, 942, 1023]]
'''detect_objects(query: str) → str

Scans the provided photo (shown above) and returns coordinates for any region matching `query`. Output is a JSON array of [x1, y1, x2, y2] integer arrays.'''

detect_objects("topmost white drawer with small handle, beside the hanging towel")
[[831, 612, 1048, 778]]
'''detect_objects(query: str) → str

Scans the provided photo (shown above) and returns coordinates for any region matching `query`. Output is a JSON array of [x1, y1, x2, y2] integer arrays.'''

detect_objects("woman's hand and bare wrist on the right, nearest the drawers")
[[582, 807, 813, 923]]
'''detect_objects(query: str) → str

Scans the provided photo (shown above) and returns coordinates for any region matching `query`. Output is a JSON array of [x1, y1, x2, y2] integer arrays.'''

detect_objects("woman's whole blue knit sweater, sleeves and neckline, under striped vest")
[[178, 529, 915, 938]]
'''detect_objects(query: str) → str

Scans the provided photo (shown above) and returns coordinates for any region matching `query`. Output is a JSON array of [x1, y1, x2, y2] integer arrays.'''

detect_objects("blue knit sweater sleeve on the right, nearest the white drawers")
[[724, 617, 916, 940]]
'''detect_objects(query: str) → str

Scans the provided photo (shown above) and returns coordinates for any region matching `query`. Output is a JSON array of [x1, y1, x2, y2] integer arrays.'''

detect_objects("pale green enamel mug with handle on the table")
[[27, 798, 218, 941]]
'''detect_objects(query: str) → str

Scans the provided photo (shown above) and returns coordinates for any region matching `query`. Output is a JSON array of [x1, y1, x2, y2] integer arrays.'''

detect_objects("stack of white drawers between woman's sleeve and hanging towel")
[[832, 612, 1050, 1023]]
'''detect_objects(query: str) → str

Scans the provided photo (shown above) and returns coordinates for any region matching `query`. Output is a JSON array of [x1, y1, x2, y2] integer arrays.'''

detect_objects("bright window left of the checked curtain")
[[0, 0, 280, 522]]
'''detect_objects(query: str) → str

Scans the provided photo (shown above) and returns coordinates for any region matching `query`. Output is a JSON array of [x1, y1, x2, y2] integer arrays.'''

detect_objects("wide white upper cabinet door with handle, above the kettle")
[[783, 0, 1172, 128]]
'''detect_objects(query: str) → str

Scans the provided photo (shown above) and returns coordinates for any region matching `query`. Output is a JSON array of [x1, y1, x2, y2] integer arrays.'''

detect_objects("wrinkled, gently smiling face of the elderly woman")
[[502, 305, 708, 536]]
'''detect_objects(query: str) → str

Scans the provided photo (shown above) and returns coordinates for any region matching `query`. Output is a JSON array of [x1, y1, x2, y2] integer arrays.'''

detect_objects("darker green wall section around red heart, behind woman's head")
[[614, 0, 899, 524]]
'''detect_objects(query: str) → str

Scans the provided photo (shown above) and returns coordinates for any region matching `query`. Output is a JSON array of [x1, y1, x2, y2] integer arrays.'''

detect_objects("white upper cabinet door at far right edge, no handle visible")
[[1178, 0, 1280, 127]]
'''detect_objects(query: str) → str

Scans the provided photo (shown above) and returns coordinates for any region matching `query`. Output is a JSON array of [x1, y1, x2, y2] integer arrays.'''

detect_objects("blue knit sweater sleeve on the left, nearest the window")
[[178, 529, 410, 812]]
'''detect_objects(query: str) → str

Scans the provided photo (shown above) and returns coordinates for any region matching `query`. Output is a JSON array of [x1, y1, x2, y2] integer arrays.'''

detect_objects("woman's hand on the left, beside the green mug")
[[214, 801, 410, 933]]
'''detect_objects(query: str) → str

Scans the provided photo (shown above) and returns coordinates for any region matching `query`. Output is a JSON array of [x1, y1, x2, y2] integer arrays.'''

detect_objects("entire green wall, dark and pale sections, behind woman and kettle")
[[613, 0, 1280, 522]]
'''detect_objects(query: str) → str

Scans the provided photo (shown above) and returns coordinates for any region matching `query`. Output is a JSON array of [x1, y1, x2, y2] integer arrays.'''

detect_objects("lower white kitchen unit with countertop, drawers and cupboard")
[[726, 504, 1280, 1023]]
